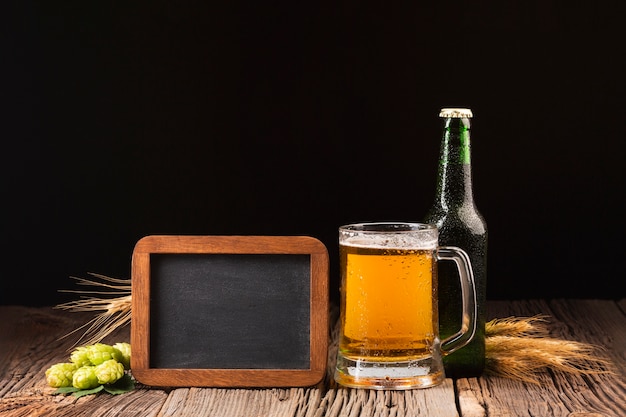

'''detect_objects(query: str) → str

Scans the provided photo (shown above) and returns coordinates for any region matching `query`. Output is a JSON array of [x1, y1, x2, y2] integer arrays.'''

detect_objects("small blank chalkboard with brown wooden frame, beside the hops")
[[131, 236, 328, 387]]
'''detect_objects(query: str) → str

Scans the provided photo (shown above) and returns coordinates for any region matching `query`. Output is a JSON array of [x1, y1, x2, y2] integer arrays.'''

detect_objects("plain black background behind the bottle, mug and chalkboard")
[[0, 0, 626, 305]]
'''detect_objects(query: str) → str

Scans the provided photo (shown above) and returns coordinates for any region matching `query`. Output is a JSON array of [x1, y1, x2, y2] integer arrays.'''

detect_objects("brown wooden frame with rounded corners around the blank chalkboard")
[[131, 235, 329, 388]]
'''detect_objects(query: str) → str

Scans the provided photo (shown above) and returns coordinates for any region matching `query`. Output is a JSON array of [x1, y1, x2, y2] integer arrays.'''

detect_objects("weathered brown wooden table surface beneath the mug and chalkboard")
[[0, 299, 626, 417]]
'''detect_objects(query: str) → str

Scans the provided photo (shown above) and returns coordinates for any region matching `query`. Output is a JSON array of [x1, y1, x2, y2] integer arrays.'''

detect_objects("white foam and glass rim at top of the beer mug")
[[339, 223, 438, 249]]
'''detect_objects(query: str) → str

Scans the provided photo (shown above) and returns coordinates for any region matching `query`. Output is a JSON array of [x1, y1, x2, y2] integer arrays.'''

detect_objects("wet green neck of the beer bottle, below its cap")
[[437, 118, 474, 208]]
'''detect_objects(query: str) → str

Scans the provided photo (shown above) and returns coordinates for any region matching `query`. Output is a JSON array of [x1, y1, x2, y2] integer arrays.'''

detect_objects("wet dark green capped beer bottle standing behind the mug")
[[425, 108, 487, 378]]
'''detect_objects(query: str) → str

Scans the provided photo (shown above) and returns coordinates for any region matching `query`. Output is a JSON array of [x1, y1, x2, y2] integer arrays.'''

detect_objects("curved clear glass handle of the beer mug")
[[436, 246, 478, 355]]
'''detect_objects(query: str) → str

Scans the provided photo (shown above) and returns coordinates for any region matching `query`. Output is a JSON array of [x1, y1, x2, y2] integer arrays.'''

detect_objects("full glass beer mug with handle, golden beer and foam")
[[335, 223, 476, 390]]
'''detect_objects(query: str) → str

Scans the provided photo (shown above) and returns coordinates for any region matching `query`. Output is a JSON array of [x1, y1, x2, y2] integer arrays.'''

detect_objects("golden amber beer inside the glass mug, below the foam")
[[340, 245, 437, 359]]
